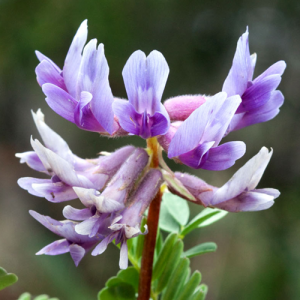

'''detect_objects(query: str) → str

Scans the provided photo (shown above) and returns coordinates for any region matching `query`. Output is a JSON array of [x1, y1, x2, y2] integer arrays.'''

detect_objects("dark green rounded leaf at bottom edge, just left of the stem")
[[98, 282, 136, 300]]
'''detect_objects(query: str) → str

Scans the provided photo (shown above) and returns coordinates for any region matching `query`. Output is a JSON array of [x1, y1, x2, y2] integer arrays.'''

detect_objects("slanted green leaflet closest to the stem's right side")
[[152, 233, 177, 281]]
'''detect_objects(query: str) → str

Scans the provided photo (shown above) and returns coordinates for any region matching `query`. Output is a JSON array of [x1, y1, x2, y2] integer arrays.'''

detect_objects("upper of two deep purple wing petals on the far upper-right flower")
[[236, 75, 281, 113]]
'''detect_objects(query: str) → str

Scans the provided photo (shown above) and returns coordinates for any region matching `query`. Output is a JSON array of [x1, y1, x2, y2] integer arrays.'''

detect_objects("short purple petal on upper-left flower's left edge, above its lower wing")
[[35, 60, 67, 91]]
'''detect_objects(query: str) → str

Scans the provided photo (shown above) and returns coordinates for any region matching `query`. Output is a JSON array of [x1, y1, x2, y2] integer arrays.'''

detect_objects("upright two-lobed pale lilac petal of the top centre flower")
[[122, 50, 169, 116]]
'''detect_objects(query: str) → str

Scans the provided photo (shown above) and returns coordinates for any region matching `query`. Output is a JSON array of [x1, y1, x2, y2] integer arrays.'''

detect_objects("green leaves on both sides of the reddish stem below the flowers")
[[98, 192, 223, 300]]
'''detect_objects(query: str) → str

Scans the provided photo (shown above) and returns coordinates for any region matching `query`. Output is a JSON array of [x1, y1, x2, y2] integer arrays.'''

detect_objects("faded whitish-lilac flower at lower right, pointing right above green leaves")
[[171, 147, 280, 212]]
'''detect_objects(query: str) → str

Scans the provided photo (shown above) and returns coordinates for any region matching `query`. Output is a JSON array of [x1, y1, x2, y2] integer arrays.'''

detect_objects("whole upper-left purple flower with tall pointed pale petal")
[[36, 20, 119, 134]]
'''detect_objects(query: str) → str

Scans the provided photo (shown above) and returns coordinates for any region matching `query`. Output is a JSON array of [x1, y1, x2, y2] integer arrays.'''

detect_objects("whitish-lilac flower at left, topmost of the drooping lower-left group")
[[16, 110, 134, 202]]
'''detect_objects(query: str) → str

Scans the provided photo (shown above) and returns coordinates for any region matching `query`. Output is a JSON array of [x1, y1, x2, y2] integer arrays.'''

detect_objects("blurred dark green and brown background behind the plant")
[[0, 0, 300, 300]]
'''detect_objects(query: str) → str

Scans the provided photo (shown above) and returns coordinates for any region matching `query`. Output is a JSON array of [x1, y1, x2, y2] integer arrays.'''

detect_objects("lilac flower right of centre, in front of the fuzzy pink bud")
[[164, 93, 245, 170]]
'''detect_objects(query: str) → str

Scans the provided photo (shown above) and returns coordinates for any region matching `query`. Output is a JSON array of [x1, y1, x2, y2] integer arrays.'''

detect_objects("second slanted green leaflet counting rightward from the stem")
[[155, 240, 183, 293]]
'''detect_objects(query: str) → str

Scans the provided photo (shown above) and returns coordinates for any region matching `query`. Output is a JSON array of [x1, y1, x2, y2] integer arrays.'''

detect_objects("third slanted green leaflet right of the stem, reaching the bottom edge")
[[162, 257, 190, 300]]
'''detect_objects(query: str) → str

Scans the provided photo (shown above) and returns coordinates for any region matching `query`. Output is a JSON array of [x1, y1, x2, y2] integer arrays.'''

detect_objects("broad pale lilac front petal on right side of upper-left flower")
[[77, 40, 114, 134]]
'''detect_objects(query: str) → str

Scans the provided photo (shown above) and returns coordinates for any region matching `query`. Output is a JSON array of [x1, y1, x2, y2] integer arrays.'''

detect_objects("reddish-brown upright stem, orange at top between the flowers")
[[138, 138, 162, 300]]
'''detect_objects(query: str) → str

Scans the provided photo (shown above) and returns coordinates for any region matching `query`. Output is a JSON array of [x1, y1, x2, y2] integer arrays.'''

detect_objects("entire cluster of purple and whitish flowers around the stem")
[[16, 21, 285, 268]]
